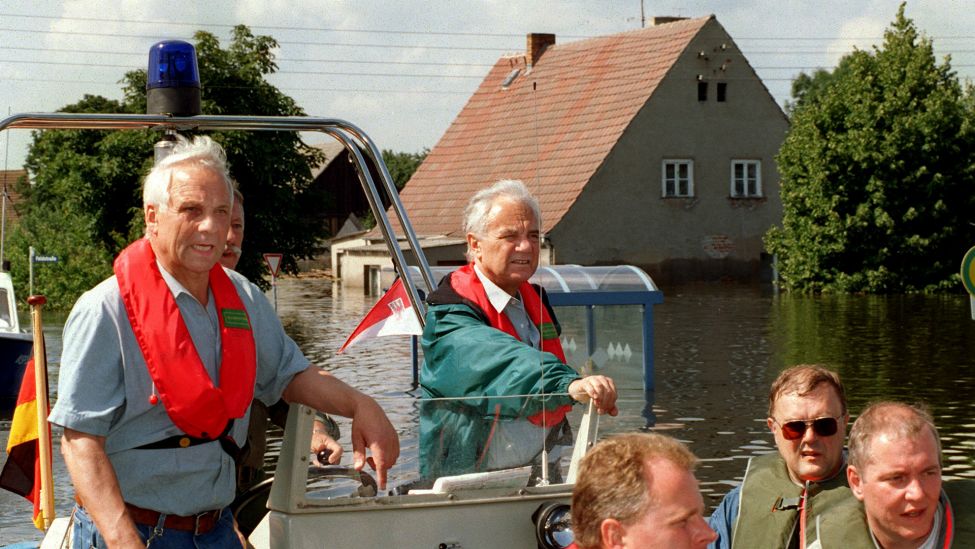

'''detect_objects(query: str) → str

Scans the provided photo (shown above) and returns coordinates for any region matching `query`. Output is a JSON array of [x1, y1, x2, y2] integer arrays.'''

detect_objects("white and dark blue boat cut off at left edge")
[[0, 272, 34, 418]]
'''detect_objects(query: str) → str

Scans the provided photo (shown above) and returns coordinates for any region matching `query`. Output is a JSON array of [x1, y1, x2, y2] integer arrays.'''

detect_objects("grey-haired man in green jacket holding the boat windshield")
[[420, 180, 617, 479]]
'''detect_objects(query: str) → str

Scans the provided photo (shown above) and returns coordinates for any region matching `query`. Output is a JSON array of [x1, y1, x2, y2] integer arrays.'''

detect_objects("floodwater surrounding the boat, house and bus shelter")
[[0, 279, 975, 545]]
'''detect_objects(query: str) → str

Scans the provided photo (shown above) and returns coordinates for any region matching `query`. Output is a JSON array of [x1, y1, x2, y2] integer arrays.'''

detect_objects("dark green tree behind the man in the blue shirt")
[[10, 25, 326, 307]]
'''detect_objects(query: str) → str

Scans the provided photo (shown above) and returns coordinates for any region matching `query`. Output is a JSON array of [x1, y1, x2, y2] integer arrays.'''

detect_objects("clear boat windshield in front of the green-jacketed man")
[[290, 394, 585, 502]]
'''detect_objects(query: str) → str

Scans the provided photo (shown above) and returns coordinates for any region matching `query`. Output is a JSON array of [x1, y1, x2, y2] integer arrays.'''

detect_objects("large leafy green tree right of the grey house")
[[765, 5, 975, 293]]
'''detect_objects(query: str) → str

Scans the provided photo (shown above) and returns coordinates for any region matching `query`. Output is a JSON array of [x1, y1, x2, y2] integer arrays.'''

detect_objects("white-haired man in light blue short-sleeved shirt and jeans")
[[50, 137, 399, 548]]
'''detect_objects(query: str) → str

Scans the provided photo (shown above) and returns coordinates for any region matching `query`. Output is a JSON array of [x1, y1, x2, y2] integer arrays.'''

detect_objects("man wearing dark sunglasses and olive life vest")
[[710, 365, 872, 549]]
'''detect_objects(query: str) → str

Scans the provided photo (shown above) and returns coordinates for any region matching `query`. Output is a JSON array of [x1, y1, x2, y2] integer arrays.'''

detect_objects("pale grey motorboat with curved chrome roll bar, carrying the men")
[[0, 66, 659, 549]]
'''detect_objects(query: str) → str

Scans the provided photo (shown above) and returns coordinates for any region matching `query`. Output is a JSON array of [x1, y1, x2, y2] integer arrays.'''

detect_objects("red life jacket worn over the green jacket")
[[450, 263, 572, 427]]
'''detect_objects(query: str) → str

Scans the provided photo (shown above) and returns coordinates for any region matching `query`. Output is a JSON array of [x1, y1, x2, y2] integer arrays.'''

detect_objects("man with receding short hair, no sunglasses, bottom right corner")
[[848, 402, 975, 549]]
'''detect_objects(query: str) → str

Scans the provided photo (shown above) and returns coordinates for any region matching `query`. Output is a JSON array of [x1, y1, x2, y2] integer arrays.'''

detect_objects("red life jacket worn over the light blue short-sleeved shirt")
[[114, 238, 257, 439]]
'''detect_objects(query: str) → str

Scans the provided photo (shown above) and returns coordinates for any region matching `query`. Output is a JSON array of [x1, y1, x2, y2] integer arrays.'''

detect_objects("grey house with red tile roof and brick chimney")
[[340, 15, 788, 285]]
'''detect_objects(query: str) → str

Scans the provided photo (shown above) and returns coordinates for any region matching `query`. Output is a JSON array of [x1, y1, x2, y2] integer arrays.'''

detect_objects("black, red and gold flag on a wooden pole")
[[0, 358, 51, 530]]
